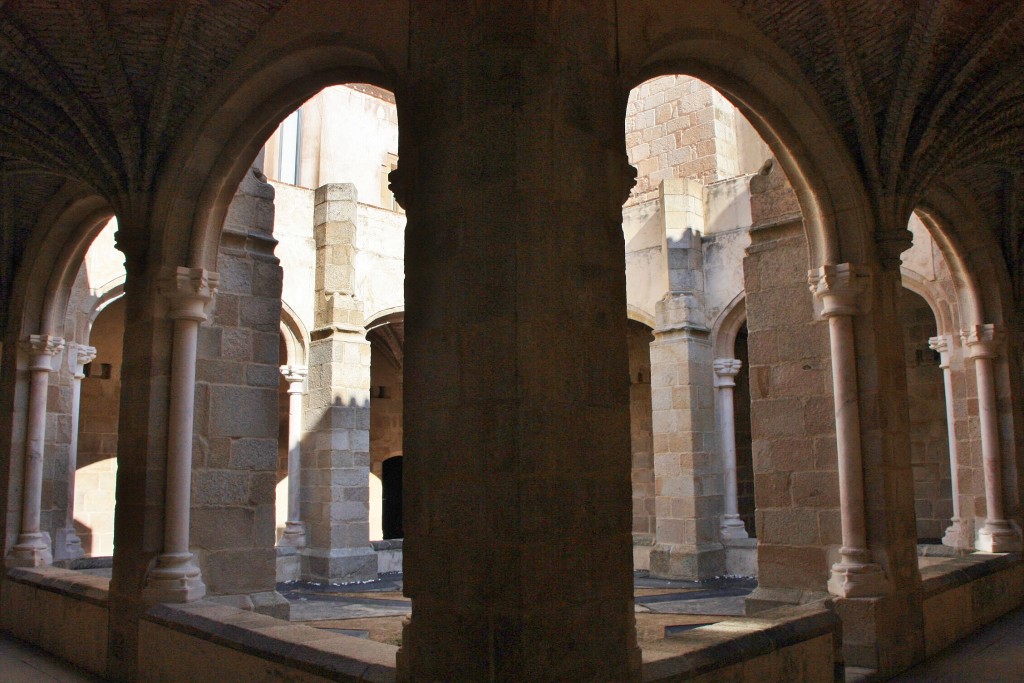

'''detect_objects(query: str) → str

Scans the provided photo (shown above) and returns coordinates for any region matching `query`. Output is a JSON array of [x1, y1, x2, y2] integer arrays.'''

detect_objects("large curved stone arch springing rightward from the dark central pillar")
[[620, 2, 874, 268]]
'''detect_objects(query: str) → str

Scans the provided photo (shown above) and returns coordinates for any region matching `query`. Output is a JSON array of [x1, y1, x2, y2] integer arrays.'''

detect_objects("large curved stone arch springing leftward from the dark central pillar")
[[153, 11, 402, 269]]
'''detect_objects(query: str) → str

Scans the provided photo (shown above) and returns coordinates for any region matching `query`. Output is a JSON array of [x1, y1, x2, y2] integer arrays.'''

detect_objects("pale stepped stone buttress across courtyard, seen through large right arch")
[[650, 189, 725, 580]]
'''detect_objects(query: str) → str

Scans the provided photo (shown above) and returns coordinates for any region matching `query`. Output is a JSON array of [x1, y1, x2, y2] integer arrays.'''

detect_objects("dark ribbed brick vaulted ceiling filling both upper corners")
[[0, 0, 1024, 315]]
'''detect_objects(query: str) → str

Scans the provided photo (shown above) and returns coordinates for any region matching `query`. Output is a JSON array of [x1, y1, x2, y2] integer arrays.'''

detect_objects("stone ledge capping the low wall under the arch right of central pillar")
[[643, 600, 842, 681]]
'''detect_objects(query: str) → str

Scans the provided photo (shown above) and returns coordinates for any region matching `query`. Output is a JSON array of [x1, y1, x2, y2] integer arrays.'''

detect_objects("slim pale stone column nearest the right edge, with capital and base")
[[961, 325, 1021, 553]]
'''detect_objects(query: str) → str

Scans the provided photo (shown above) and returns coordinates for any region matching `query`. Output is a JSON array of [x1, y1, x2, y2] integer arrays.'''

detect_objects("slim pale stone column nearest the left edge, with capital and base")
[[7, 335, 65, 566]]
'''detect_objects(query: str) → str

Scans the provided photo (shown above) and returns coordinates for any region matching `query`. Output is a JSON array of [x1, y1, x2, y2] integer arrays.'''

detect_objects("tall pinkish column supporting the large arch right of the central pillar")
[[808, 263, 888, 598]]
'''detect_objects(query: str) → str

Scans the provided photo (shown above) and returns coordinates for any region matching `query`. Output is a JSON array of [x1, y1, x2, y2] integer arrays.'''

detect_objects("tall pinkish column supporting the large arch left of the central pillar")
[[144, 267, 219, 602]]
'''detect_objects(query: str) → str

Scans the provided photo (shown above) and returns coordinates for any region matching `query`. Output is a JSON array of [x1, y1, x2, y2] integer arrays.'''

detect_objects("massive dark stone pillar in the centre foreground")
[[392, 3, 640, 681]]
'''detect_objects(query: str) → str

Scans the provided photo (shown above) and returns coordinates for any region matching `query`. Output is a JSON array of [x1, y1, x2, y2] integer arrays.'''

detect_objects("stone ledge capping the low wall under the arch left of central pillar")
[[142, 602, 398, 683]]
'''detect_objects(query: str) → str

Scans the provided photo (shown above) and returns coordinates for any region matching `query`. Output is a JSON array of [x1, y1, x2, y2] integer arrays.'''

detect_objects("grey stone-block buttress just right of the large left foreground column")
[[190, 166, 282, 608]]
